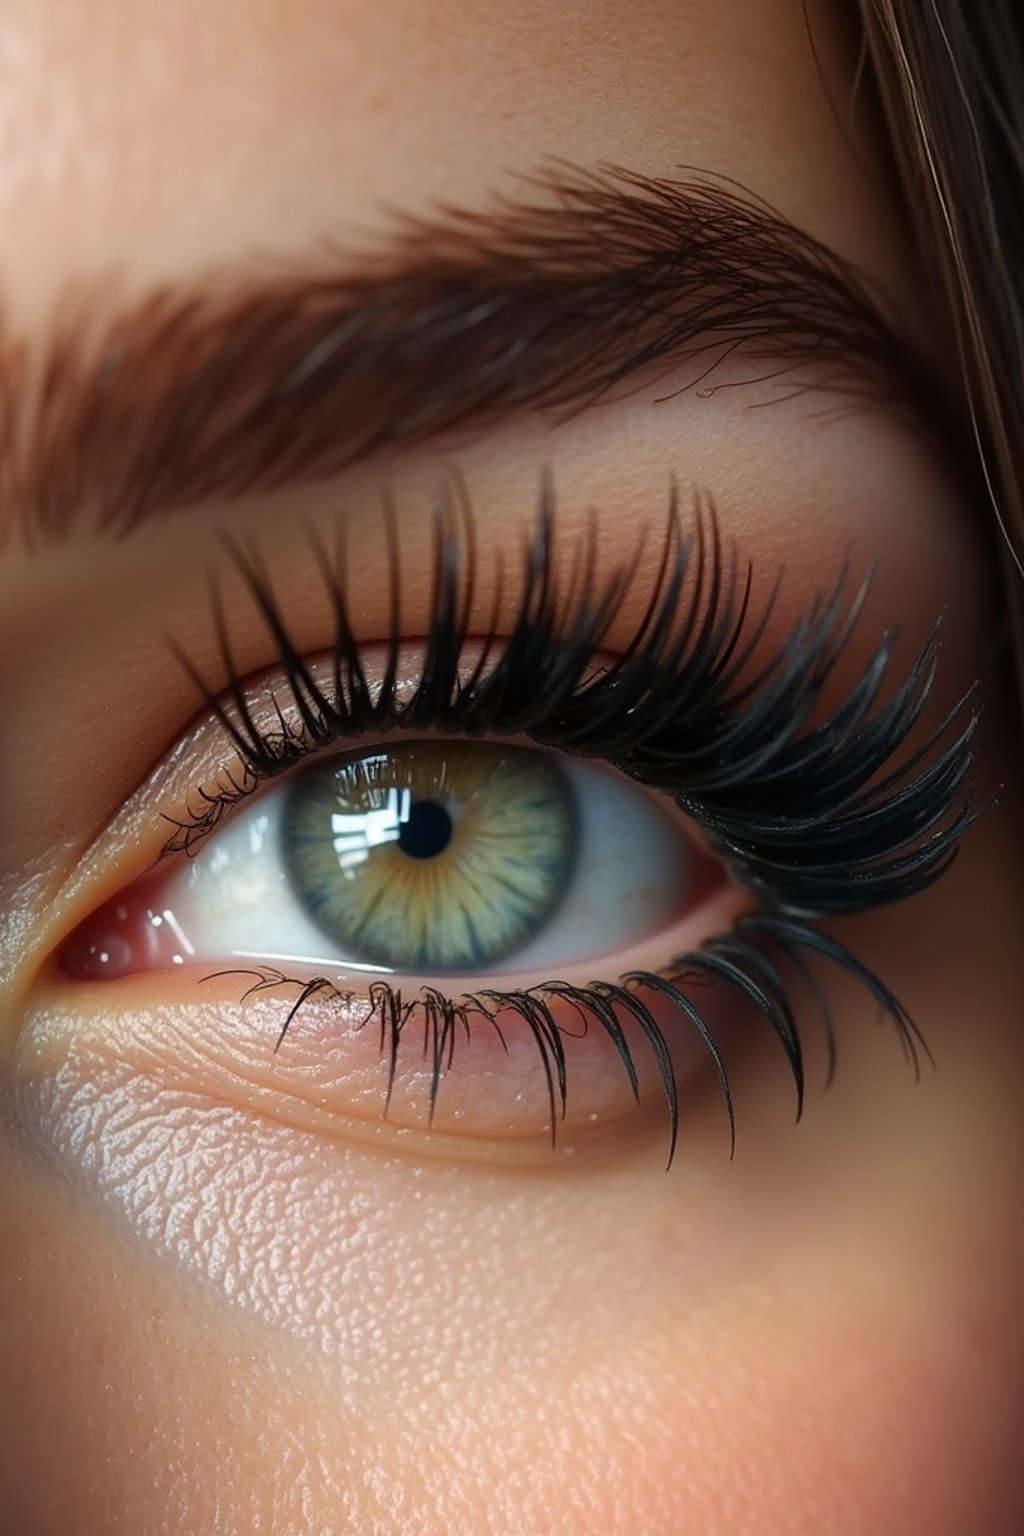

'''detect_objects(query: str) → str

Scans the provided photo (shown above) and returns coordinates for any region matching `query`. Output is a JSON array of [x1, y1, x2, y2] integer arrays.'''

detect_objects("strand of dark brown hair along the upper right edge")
[[860, 0, 1024, 664]]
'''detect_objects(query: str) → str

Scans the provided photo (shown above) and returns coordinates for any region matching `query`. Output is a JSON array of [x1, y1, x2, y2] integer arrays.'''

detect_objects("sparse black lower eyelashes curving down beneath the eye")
[[204, 912, 932, 1167]]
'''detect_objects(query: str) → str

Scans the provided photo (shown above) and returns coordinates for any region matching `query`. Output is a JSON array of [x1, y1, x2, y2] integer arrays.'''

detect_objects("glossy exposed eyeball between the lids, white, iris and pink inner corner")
[[64, 739, 706, 975]]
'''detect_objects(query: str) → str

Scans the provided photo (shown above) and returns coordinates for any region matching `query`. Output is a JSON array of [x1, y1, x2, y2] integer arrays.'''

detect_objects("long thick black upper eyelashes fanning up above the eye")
[[167, 478, 979, 917]]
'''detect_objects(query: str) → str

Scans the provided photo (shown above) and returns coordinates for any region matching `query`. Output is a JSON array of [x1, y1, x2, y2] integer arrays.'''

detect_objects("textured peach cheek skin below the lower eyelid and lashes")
[[0, 823, 1024, 1536]]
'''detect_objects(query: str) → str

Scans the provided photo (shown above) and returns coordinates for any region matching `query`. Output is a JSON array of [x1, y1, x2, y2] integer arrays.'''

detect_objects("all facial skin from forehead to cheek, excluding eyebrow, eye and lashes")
[[0, 0, 1024, 1536]]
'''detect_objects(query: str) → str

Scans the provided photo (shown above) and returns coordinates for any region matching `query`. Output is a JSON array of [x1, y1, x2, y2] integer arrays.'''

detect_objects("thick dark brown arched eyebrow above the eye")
[[0, 166, 926, 545]]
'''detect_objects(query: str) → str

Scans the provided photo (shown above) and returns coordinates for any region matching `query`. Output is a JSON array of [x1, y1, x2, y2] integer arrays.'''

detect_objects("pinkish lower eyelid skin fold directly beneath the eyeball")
[[18, 888, 743, 1167]]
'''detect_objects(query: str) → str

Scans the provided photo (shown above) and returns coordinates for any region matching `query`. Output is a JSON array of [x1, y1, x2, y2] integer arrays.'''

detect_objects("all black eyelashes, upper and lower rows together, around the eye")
[[164, 478, 978, 1164]]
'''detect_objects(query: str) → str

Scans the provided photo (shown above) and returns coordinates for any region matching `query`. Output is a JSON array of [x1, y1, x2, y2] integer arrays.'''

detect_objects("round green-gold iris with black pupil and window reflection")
[[282, 740, 576, 972]]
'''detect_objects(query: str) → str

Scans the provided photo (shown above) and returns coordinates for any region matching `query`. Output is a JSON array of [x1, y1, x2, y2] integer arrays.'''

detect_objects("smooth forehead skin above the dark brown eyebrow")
[[0, 0, 900, 306]]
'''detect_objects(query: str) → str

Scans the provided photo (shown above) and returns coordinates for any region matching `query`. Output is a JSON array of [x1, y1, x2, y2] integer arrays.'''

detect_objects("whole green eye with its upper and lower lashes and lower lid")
[[47, 505, 976, 1161]]
